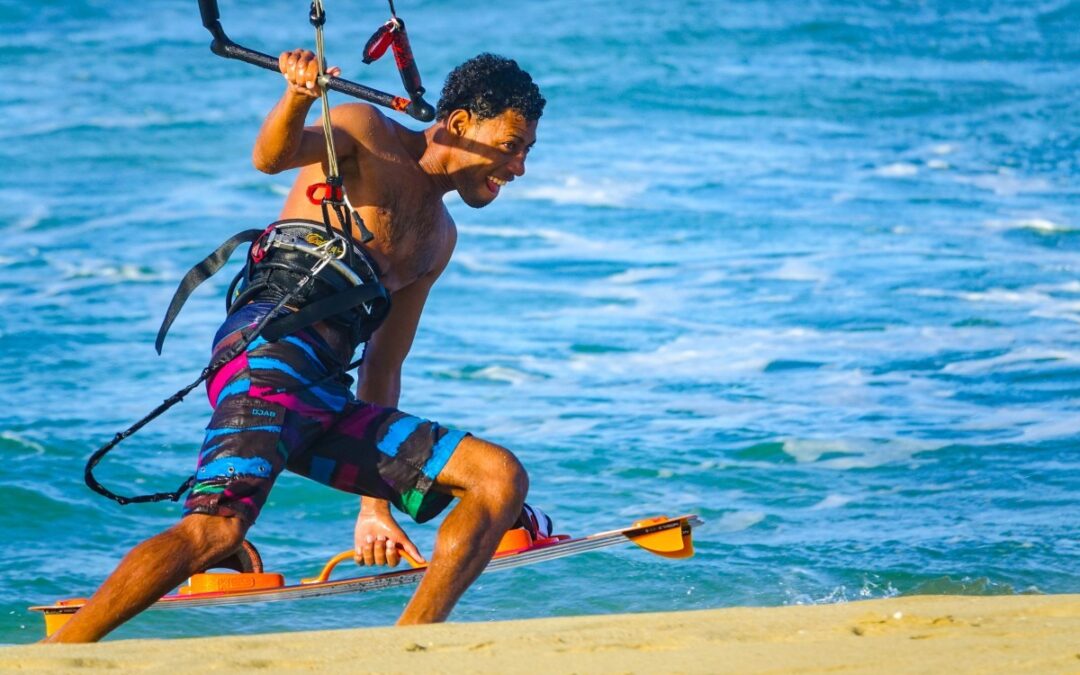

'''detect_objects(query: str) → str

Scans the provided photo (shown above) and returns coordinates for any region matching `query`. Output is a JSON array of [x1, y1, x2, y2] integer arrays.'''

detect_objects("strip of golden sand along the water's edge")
[[0, 594, 1080, 673]]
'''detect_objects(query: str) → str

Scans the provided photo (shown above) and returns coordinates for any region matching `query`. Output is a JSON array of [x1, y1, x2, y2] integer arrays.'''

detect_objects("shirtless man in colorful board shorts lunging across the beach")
[[49, 50, 544, 643]]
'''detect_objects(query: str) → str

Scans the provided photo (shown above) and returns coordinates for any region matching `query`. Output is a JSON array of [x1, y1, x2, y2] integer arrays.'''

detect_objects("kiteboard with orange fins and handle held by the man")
[[30, 515, 702, 633]]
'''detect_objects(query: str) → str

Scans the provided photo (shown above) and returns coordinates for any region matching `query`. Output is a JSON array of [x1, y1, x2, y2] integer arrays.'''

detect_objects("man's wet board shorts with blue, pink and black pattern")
[[184, 303, 467, 524]]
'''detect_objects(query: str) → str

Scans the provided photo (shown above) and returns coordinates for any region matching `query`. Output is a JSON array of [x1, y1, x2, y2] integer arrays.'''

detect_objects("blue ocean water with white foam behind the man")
[[0, 0, 1080, 644]]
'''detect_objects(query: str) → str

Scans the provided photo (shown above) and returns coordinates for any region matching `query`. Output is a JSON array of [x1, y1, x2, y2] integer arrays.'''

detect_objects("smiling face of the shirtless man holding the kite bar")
[[450, 110, 537, 208]]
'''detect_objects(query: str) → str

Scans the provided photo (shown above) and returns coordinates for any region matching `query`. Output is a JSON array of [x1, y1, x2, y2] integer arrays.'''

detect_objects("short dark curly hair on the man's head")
[[436, 53, 546, 122]]
